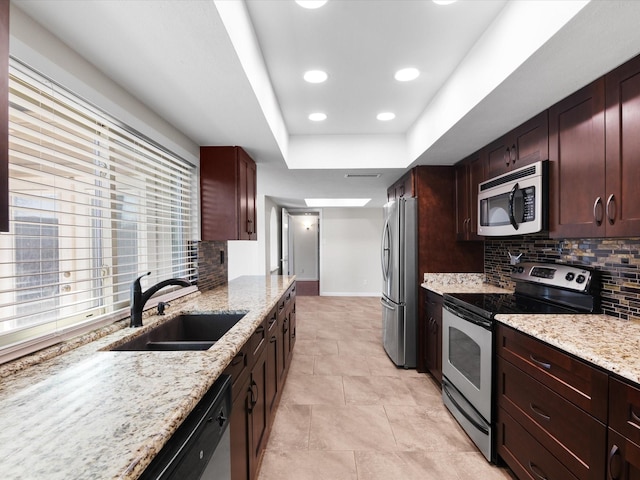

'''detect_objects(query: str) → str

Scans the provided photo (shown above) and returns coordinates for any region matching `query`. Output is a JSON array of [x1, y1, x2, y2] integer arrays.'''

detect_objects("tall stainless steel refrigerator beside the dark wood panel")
[[381, 198, 418, 368]]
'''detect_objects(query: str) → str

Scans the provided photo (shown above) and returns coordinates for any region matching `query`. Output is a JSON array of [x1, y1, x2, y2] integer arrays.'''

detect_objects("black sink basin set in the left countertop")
[[111, 313, 246, 351]]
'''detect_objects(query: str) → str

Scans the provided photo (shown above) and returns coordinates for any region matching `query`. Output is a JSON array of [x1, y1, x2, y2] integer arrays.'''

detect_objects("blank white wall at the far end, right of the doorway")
[[320, 208, 384, 296]]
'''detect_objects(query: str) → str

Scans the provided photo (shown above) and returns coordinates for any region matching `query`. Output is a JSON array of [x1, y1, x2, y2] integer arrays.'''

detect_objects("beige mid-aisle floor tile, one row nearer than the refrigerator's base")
[[344, 376, 416, 405]]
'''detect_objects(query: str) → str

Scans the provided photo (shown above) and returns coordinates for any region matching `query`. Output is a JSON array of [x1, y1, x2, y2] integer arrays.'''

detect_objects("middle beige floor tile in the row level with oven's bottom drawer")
[[309, 405, 396, 451]]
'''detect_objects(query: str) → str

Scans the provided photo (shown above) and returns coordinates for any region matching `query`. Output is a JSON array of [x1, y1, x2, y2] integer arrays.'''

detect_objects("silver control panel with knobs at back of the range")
[[511, 263, 593, 292]]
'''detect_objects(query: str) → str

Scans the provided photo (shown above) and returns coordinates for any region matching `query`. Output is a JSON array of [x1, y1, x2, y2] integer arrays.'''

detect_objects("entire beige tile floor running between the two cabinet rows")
[[259, 296, 512, 480]]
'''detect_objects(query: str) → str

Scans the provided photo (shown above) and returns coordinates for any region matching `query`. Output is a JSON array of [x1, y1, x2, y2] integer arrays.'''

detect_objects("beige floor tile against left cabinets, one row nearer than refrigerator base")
[[280, 373, 345, 405]]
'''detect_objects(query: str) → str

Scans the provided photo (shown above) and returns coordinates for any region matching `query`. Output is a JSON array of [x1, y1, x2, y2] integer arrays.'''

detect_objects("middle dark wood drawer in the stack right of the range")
[[498, 358, 607, 480]]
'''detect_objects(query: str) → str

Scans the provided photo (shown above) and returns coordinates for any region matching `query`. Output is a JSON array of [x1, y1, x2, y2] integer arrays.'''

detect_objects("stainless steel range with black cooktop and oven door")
[[442, 263, 600, 462]]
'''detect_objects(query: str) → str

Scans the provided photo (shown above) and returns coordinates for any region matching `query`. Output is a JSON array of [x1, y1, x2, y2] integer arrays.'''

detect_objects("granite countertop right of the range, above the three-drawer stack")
[[496, 314, 640, 383]]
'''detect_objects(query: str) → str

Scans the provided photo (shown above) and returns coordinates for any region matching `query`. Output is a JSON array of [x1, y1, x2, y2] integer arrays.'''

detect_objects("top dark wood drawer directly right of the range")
[[496, 324, 609, 422]]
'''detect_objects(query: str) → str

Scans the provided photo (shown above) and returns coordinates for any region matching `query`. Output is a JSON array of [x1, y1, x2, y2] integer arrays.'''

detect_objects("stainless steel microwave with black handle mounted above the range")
[[478, 160, 549, 237]]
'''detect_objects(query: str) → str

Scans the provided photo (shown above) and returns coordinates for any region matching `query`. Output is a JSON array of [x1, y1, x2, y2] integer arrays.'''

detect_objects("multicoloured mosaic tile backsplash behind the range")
[[484, 235, 640, 321]]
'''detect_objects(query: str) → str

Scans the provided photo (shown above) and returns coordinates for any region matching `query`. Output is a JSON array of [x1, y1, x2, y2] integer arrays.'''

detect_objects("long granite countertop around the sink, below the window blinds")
[[0, 276, 295, 480]]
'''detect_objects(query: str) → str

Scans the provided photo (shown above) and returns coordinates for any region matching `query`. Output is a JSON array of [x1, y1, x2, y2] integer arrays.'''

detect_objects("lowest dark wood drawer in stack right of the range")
[[497, 408, 578, 480]]
